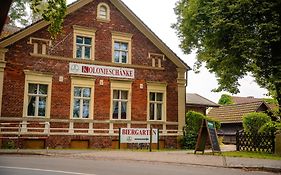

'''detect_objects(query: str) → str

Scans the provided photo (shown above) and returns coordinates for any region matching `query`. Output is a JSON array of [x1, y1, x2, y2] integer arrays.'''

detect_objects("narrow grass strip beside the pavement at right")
[[211, 151, 281, 160]]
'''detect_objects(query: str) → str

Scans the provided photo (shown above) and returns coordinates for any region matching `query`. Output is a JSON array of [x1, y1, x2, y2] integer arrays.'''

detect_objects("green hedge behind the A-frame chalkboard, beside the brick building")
[[180, 111, 220, 149]]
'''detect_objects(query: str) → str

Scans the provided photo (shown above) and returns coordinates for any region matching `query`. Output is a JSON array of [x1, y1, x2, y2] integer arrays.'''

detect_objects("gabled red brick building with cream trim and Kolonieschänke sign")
[[0, 0, 190, 148]]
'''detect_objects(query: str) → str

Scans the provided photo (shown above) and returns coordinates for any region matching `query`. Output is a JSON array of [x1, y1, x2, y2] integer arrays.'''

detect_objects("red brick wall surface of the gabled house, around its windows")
[[2, 0, 178, 147]]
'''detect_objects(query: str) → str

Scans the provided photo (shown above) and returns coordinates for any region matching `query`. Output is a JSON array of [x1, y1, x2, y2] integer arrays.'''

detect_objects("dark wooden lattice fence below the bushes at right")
[[236, 130, 275, 153]]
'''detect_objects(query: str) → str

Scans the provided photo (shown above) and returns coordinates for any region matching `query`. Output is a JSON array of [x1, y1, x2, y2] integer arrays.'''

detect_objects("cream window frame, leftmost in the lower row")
[[23, 70, 53, 118]]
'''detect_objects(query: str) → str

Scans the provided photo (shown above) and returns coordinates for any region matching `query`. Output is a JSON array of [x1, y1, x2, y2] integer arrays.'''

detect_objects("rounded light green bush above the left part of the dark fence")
[[243, 112, 271, 133]]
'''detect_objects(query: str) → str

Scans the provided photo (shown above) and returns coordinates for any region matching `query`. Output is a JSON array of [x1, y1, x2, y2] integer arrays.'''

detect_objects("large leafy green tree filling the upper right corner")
[[173, 0, 281, 112]]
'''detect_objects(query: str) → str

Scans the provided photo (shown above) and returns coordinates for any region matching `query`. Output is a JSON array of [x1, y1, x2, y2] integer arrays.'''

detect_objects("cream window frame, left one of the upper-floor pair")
[[73, 25, 96, 60]]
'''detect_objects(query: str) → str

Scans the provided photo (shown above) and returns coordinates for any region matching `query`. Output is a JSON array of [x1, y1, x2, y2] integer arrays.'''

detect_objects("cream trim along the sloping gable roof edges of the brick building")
[[0, 0, 191, 70]]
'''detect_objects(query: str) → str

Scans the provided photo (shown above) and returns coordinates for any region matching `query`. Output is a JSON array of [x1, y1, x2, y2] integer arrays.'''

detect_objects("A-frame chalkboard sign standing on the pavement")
[[194, 119, 221, 154]]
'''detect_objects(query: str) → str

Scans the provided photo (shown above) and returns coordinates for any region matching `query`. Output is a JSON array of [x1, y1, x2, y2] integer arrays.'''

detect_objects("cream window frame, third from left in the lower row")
[[110, 80, 132, 121]]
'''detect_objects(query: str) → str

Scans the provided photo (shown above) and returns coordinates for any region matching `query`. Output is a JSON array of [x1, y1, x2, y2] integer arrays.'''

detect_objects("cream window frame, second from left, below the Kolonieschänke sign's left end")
[[70, 76, 95, 120]]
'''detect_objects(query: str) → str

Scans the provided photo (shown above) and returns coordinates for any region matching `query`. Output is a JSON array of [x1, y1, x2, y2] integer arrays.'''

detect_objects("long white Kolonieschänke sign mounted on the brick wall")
[[69, 63, 135, 79]]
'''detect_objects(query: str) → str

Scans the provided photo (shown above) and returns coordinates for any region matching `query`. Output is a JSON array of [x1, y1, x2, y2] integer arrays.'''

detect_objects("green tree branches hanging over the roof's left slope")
[[9, 0, 66, 38]]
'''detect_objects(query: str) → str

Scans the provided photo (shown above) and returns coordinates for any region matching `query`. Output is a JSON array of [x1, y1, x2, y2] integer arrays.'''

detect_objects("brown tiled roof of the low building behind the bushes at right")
[[207, 101, 269, 123]]
